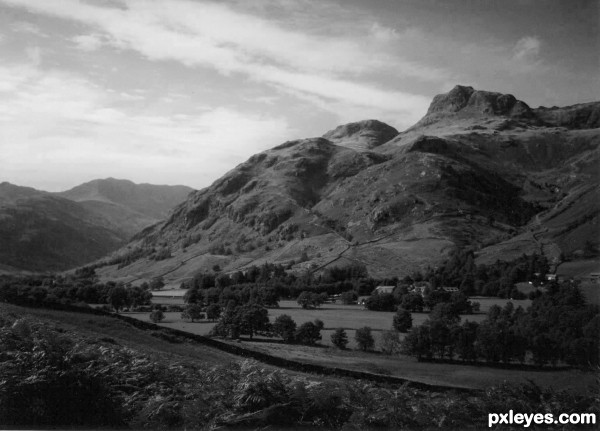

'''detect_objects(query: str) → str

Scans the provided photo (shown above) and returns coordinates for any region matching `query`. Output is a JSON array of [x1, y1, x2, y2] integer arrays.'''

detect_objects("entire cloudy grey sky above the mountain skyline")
[[0, 0, 600, 191]]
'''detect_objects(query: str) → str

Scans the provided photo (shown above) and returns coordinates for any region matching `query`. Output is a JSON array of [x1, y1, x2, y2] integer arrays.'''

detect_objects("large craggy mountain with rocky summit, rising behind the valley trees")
[[88, 86, 600, 282]]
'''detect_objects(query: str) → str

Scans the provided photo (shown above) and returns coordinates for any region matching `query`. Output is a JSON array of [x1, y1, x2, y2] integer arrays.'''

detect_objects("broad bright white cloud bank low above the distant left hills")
[[0, 64, 291, 189]]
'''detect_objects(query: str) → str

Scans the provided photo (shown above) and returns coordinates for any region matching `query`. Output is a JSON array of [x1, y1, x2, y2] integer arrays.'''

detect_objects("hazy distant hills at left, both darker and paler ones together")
[[0, 179, 192, 272]]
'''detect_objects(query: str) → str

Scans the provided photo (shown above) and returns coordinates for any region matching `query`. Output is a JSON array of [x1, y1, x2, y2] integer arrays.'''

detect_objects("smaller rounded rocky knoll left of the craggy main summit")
[[323, 120, 398, 151]]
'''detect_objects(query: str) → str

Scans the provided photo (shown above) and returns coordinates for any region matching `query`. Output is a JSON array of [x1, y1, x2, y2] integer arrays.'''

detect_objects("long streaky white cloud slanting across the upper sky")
[[2, 0, 436, 126]]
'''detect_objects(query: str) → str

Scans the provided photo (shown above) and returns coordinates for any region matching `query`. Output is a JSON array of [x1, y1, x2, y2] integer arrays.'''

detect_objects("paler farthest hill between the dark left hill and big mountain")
[[56, 178, 194, 238]]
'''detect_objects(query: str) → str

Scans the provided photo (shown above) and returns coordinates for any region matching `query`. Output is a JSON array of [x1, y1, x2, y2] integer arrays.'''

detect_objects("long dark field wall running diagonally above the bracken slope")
[[2, 301, 481, 394]]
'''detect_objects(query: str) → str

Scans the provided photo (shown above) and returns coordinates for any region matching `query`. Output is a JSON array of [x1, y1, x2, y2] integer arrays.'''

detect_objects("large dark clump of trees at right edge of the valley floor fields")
[[403, 283, 600, 366]]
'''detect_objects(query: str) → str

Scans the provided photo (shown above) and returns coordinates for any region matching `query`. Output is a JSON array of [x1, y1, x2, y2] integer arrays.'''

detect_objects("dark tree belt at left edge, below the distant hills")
[[0, 268, 152, 312]]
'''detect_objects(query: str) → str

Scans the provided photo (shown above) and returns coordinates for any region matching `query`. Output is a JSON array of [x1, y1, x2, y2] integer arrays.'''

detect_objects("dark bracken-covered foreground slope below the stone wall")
[[0, 304, 597, 430]]
